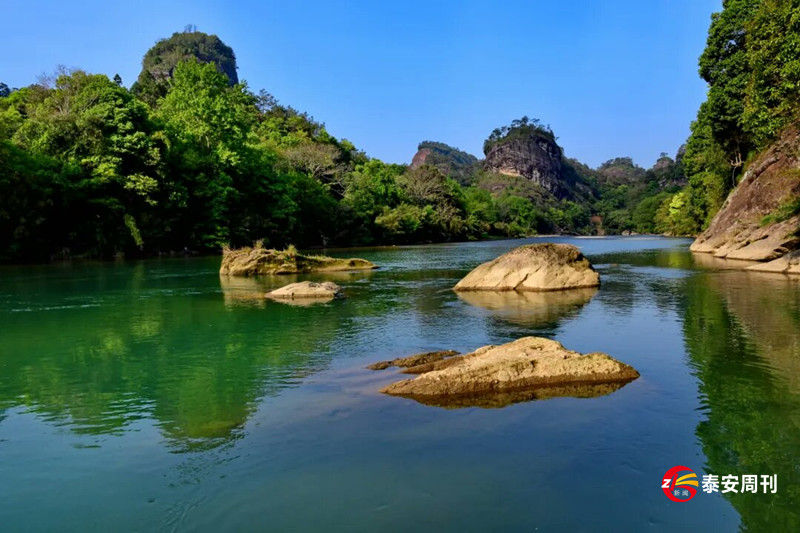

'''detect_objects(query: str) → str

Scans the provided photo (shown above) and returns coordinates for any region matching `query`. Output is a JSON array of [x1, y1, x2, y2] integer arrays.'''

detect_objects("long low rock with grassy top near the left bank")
[[219, 243, 378, 276]]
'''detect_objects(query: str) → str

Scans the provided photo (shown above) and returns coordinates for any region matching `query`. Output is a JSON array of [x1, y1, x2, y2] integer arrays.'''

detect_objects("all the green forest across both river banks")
[[0, 0, 800, 261]]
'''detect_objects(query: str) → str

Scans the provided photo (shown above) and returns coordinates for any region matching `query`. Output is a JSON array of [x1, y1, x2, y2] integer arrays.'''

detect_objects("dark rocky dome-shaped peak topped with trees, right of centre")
[[484, 132, 566, 197]]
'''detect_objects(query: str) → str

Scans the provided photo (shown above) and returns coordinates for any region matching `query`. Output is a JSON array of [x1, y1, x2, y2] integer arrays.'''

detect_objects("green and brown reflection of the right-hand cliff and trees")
[[684, 272, 800, 531]]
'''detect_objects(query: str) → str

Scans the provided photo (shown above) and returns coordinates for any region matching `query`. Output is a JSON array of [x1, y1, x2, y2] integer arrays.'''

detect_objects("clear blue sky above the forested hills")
[[0, 0, 721, 167]]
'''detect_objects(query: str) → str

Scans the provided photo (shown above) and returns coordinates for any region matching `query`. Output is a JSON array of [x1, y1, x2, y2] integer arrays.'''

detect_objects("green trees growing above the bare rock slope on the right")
[[661, 0, 800, 234]]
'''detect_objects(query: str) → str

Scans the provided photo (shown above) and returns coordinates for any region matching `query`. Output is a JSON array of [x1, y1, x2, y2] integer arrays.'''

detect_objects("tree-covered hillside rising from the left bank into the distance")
[[0, 30, 696, 261]]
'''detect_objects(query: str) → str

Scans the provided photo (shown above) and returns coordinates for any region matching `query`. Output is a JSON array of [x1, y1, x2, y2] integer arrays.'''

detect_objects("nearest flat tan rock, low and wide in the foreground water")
[[381, 337, 639, 407]]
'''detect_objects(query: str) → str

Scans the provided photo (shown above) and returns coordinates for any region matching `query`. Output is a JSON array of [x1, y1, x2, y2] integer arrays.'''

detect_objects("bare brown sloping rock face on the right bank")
[[691, 131, 800, 261]]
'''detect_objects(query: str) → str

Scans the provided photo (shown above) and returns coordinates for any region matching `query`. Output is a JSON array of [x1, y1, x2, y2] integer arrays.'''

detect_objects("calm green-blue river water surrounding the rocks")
[[0, 237, 800, 532]]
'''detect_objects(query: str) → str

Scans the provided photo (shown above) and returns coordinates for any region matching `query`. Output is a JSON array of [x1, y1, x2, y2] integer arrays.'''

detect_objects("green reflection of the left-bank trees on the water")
[[0, 264, 356, 451]]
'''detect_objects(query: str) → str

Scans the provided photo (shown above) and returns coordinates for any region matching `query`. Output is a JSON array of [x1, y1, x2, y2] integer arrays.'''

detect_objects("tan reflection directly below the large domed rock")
[[457, 287, 597, 326]]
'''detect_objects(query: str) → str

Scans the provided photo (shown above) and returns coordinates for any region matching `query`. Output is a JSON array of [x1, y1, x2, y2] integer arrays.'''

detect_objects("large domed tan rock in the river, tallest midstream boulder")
[[453, 243, 600, 291]]
